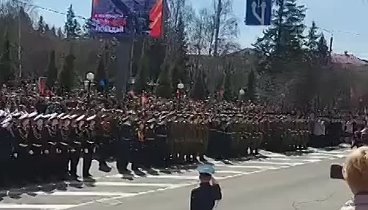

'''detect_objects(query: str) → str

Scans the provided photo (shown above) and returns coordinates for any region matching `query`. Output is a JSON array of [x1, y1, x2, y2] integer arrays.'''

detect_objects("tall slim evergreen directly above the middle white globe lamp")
[[172, 16, 189, 84]]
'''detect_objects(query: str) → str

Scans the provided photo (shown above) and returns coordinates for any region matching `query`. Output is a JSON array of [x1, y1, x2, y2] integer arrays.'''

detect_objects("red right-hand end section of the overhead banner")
[[150, 0, 163, 38]]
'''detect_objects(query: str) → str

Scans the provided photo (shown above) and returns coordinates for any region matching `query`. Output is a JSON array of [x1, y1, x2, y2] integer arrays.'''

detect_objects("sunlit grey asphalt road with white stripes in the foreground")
[[0, 150, 351, 210]]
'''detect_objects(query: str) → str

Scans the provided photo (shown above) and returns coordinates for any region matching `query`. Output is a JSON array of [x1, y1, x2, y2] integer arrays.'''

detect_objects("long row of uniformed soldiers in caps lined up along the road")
[[0, 104, 316, 186]]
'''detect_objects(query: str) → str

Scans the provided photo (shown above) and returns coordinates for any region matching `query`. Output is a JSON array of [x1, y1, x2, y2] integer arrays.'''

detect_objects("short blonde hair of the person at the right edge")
[[344, 147, 368, 194]]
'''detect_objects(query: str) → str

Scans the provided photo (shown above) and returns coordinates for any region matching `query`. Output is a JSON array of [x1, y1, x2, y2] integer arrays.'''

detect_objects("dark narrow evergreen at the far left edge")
[[0, 37, 14, 84]]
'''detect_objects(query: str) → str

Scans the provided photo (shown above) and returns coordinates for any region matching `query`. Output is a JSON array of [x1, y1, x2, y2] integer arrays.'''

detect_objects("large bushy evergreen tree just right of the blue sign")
[[254, 0, 306, 71]]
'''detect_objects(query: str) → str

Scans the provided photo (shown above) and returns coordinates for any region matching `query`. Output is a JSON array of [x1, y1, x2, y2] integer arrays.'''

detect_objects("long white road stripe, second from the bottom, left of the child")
[[32, 191, 136, 197]]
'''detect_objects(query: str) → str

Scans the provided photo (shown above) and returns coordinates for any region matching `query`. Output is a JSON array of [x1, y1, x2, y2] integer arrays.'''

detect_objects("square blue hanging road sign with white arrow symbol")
[[245, 0, 272, 26]]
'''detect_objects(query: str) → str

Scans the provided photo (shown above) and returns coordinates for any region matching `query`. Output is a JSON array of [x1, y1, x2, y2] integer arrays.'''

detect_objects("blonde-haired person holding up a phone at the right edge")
[[331, 146, 368, 210]]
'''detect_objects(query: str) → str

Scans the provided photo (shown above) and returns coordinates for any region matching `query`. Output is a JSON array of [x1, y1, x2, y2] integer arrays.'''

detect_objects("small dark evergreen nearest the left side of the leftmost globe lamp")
[[60, 53, 75, 91]]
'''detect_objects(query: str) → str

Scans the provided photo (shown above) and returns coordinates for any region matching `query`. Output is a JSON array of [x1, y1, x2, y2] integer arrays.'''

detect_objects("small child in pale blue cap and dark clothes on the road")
[[190, 165, 222, 210]]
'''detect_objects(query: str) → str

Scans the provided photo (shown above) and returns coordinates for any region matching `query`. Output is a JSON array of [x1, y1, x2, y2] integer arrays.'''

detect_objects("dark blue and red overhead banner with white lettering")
[[91, 0, 163, 38]]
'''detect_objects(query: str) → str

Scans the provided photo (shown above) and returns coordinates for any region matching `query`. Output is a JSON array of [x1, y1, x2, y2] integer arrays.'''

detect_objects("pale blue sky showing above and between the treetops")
[[34, 0, 368, 58]]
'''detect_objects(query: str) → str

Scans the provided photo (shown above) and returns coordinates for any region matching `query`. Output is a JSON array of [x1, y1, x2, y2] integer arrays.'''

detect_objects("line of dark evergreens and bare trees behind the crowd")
[[0, 0, 364, 106]]
